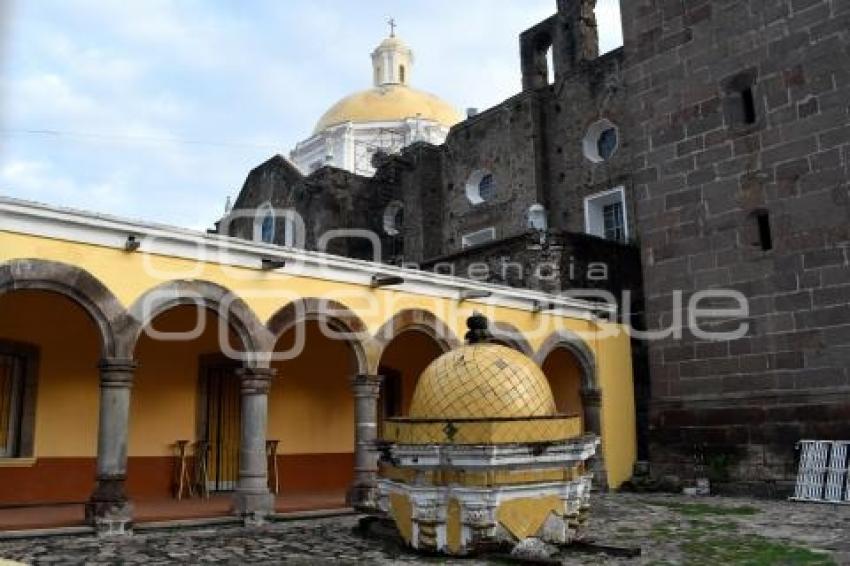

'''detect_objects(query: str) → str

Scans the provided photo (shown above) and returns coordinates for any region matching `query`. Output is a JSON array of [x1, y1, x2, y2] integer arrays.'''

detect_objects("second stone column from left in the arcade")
[[233, 367, 275, 524]]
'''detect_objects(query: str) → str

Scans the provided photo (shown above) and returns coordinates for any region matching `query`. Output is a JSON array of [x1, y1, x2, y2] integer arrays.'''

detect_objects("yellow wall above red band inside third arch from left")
[[268, 322, 354, 454]]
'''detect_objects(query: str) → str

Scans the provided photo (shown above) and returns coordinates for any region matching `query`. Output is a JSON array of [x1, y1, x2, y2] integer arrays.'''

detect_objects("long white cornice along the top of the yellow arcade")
[[0, 197, 616, 320]]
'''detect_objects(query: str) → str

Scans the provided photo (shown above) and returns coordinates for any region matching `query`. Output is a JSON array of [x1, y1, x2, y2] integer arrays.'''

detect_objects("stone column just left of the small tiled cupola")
[[348, 375, 383, 512]]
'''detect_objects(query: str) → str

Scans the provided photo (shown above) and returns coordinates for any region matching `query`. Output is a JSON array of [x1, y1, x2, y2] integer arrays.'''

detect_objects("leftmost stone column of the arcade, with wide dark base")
[[86, 358, 136, 534]]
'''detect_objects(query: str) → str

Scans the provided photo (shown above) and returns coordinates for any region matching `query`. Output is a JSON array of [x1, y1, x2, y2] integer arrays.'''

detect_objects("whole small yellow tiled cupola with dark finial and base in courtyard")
[[378, 314, 599, 554]]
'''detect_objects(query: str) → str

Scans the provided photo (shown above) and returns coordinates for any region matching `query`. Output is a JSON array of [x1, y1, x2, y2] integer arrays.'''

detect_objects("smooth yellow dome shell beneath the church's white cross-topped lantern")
[[313, 84, 461, 134]]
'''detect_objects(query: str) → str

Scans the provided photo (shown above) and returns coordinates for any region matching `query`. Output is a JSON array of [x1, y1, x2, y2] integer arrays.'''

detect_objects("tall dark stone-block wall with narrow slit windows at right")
[[621, 0, 850, 480]]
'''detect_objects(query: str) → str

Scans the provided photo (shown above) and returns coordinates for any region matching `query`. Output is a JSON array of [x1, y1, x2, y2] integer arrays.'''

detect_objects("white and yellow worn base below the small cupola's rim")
[[378, 437, 598, 555]]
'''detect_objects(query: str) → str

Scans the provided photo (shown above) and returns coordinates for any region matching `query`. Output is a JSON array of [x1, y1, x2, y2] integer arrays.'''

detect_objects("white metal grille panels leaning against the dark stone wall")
[[791, 440, 850, 505]]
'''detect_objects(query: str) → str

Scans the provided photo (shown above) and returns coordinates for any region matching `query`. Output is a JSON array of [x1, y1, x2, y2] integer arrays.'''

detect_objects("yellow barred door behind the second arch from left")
[[204, 366, 241, 491]]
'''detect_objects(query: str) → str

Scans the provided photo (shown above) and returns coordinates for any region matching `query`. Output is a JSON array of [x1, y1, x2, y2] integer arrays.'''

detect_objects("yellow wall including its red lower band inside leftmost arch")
[[0, 291, 100, 503]]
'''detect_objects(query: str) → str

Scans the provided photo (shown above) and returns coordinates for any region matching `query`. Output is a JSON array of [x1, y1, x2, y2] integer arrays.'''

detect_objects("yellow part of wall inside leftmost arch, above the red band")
[[0, 291, 100, 458]]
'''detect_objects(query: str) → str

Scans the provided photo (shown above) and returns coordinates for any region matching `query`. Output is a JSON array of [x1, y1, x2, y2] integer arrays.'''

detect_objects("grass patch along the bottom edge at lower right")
[[681, 536, 835, 566]]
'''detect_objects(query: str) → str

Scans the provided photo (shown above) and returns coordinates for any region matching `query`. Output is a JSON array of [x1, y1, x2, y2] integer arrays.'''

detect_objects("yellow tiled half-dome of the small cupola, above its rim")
[[410, 343, 556, 420]]
